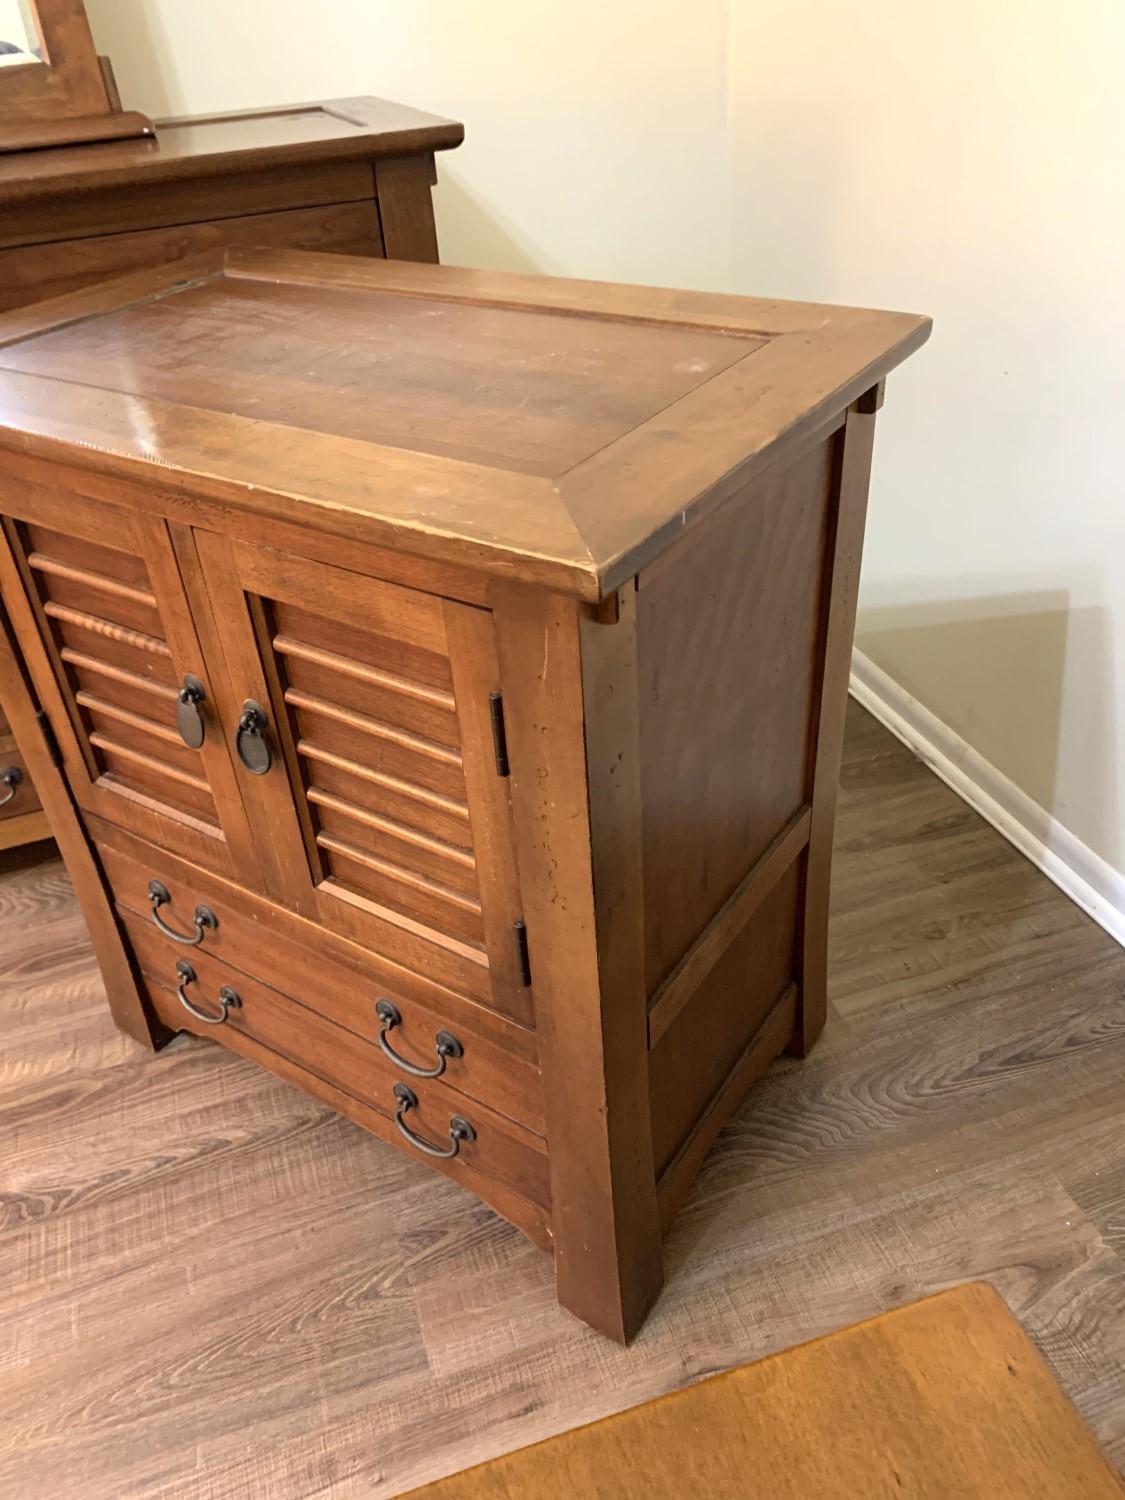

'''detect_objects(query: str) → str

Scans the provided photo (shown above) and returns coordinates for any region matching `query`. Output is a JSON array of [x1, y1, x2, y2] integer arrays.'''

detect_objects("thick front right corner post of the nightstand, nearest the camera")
[[494, 584, 663, 1343]]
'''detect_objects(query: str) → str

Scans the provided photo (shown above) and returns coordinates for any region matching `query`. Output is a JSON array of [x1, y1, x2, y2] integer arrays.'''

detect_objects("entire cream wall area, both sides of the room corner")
[[89, 0, 1125, 870]]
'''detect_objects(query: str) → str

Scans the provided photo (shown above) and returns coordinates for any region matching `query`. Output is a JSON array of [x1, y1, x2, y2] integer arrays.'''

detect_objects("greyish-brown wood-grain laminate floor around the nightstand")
[[0, 705, 1125, 1500]]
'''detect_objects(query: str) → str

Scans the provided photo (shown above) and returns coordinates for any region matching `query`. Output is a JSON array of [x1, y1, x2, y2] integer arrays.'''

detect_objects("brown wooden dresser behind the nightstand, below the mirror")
[[0, 98, 465, 309]]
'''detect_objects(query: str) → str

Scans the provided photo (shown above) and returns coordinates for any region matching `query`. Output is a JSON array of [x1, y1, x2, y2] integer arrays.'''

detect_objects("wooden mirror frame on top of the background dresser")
[[0, 0, 153, 152]]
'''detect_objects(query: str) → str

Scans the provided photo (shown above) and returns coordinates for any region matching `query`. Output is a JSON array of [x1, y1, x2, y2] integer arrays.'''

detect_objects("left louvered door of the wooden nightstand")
[[0, 479, 255, 884]]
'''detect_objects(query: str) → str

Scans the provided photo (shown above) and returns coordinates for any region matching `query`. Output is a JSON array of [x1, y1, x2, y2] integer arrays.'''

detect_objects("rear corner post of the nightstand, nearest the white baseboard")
[[788, 381, 884, 1058]]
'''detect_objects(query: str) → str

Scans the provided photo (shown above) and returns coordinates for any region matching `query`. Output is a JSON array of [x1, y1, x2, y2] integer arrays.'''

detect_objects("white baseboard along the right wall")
[[851, 651, 1125, 947]]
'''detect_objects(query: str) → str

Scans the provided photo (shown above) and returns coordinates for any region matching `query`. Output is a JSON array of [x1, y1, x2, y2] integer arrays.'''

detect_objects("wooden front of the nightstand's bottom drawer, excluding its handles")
[[125, 914, 549, 1208]]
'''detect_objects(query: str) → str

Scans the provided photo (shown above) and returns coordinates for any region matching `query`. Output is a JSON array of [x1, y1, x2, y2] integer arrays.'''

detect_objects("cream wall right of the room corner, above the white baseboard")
[[731, 0, 1125, 872]]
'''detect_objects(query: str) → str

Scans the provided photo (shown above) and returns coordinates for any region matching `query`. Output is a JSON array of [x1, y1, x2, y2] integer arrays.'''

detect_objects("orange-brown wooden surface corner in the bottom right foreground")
[[410, 1281, 1125, 1500]]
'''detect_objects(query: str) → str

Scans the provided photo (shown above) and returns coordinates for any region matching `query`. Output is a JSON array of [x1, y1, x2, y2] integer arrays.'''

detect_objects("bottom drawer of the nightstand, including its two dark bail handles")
[[125, 914, 549, 1227]]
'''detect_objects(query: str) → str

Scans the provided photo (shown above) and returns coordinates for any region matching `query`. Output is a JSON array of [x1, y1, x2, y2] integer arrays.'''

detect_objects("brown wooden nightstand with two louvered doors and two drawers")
[[0, 252, 929, 1338]]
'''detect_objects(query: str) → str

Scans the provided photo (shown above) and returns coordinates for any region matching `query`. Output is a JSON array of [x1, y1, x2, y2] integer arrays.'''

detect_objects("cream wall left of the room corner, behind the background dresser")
[[87, 0, 729, 287]]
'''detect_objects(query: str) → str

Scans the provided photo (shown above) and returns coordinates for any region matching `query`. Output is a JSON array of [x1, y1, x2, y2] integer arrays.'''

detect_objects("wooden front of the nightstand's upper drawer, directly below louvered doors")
[[98, 842, 545, 1134]]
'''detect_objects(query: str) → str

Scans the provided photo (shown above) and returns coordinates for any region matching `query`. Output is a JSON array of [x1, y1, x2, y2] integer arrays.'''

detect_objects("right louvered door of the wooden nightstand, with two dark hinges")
[[198, 534, 531, 1023]]
